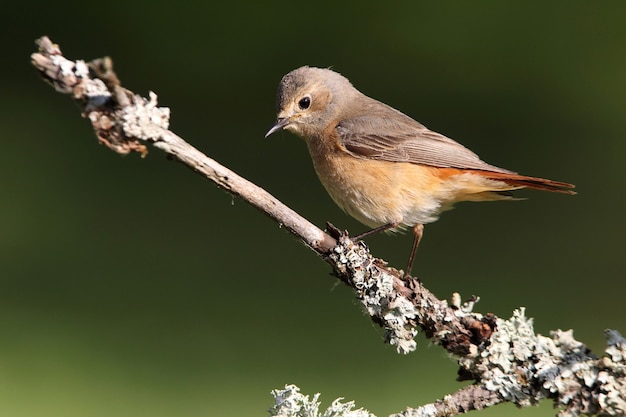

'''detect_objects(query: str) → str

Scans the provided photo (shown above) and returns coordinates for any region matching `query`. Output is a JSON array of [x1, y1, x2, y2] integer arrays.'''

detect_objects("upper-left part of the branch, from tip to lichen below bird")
[[32, 37, 335, 254]]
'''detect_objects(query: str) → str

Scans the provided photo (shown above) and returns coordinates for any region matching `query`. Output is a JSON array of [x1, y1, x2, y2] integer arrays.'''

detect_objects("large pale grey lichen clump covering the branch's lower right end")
[[459, 308, 626, 417]]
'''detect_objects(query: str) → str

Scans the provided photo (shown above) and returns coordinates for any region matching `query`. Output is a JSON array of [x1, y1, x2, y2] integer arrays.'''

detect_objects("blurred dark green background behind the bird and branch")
[[0, 0, 626, 417]]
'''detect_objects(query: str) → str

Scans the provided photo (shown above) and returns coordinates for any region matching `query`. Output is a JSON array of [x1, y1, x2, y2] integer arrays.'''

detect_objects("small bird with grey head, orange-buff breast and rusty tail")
[[265, 66, 575, 276]]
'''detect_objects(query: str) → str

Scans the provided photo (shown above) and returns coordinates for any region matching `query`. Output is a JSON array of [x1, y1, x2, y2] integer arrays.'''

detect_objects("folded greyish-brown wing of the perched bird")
[[336, 98, 513, 173]]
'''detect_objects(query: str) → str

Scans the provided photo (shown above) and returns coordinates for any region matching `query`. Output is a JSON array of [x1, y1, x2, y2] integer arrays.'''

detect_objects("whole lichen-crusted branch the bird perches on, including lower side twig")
[[32, 37, 626, 417]]
